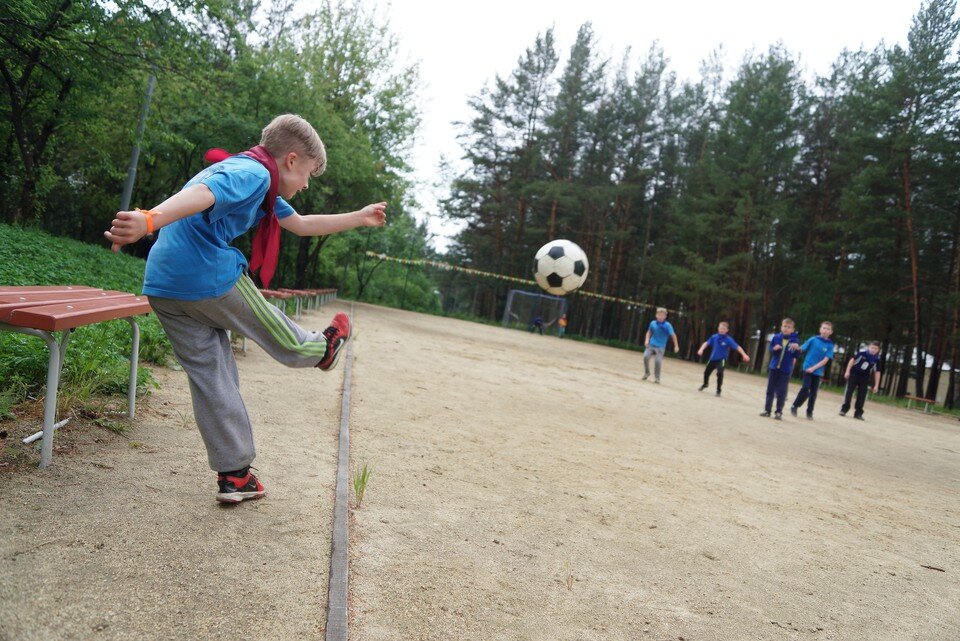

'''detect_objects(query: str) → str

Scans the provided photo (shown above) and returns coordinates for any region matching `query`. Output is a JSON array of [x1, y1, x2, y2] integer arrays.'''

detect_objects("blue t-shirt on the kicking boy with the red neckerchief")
[[143, 156, 294, 300]]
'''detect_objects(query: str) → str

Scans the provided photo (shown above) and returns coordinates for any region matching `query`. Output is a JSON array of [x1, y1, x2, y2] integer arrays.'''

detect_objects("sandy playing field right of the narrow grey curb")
[[351, 306, 960, 641]]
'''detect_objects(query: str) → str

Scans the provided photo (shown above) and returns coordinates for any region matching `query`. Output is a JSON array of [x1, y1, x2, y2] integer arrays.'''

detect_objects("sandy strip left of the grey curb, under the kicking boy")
[[0, 305, 352, 641]]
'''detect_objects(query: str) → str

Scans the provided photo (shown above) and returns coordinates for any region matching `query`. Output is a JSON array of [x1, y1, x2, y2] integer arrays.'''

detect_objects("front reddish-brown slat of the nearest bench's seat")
[[6, 294, 152, 332]]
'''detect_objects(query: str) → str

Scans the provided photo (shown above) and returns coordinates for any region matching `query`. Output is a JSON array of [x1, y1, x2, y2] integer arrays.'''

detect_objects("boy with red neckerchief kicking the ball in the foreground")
[[104, 114, 386, 503]]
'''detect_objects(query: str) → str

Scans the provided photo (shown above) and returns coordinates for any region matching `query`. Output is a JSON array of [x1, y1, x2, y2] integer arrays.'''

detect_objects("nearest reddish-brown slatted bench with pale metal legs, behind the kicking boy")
[[0, 285, 151, 467]]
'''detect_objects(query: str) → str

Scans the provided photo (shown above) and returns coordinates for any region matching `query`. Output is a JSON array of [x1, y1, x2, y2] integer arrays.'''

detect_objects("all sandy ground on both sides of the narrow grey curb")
[[0, 305, 960, 641]]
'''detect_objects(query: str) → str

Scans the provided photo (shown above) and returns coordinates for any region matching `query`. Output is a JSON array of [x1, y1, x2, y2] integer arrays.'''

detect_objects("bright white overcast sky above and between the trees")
[[365, 0, 921, 249]]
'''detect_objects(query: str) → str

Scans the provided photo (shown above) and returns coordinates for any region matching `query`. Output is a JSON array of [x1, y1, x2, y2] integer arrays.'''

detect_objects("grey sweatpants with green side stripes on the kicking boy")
[[148, 276, 327, 472]]
